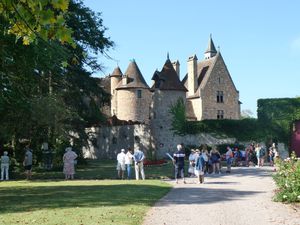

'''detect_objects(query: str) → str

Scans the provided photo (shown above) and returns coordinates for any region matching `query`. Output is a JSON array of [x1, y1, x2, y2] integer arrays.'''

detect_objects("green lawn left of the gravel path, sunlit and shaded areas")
[[0, 161, 173, 225]]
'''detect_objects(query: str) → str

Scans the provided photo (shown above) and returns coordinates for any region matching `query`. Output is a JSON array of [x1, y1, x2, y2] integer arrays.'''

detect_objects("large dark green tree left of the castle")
[[0, 1, 113, 164]]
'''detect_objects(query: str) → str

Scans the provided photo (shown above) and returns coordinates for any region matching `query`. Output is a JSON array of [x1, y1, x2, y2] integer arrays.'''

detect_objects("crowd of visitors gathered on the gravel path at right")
[[173, 143, 279, 184]]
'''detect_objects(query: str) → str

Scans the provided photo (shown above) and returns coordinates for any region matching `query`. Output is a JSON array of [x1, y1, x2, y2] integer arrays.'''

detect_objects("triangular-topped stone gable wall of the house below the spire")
[[201, 56, 240, 119]]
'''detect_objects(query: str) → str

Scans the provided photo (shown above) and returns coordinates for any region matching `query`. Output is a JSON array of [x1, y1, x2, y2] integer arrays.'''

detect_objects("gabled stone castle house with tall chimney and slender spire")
[[183, 37, 240, 120]]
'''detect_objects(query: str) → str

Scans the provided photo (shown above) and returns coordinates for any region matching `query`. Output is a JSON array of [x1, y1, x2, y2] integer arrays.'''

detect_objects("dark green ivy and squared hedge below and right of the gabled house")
[[171, 98, 300, 144]]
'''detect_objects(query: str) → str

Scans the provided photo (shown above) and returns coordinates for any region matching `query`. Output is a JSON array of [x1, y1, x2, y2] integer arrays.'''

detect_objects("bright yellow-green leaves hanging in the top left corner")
[[0, 0, 75, 46]]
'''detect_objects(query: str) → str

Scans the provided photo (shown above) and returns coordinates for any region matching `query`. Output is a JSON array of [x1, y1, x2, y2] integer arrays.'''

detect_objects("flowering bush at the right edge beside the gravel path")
[[274, 152, 300, 202]]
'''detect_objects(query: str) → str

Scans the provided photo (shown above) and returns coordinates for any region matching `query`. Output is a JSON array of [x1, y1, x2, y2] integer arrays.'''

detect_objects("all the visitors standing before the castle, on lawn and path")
[[0, 143, 279, 183]]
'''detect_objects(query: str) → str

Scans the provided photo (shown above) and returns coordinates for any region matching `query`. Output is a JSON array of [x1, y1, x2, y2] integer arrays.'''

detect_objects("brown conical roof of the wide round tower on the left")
[[116, 60, 149, 90]]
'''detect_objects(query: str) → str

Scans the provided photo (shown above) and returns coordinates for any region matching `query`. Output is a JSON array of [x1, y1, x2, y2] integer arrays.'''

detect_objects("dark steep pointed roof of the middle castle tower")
[[151, 59, 187, 92]]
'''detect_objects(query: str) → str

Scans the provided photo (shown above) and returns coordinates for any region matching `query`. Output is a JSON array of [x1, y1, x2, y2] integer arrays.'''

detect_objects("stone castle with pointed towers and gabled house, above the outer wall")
[[109, 34, 240, 124]]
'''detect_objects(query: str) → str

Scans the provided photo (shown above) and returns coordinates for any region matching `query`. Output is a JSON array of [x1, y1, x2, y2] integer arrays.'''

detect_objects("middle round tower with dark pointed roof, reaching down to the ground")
[[150, 58, 187, 157]]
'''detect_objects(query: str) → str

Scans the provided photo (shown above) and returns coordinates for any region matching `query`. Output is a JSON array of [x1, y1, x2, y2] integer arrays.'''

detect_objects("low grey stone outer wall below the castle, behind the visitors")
[[83, 125, 235, 159]]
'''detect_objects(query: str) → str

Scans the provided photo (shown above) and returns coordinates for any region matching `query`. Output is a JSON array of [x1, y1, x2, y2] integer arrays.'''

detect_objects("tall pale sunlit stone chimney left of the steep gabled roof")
[[187, 55, 198, 96]]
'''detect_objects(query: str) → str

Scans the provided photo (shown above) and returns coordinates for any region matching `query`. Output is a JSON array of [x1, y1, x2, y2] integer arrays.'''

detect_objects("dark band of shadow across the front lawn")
[[0, 183, 170, 214]]
